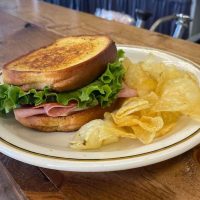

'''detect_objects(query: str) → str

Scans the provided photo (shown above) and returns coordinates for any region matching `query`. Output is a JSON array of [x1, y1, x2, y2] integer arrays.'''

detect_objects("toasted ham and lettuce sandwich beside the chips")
[[0, 35, 134, 132]]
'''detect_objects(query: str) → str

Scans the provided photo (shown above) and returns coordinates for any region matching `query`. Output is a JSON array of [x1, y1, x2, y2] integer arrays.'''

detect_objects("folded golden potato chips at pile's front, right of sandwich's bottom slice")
[[111, 92, 164, 144]]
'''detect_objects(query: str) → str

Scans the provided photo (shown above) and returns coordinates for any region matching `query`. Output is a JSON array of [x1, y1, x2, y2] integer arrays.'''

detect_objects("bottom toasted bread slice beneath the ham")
[[16, 102, 118, 132]]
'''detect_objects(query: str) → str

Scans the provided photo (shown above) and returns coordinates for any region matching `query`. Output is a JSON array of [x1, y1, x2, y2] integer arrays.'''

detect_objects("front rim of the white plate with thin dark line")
[[0, 130, 200, 172]]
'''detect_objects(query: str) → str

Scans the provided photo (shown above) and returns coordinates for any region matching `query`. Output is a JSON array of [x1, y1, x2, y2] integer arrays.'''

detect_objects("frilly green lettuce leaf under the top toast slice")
[[0, 50, 125, 116]]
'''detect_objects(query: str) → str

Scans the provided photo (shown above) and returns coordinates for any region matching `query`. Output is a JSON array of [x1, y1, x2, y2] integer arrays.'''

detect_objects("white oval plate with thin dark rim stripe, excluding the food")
[[0, 45, 200, 171]]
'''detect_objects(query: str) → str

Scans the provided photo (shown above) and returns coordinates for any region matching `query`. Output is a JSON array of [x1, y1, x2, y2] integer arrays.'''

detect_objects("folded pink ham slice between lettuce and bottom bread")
[[14, 103, 80, 118]]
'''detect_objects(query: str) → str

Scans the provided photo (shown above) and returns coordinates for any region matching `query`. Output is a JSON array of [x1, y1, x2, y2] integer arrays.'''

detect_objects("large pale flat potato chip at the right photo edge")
[[153, 78, 200, 115]]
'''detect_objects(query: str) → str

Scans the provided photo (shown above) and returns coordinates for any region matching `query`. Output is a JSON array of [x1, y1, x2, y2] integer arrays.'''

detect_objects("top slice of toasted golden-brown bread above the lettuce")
[[3, 35, 117, 92]]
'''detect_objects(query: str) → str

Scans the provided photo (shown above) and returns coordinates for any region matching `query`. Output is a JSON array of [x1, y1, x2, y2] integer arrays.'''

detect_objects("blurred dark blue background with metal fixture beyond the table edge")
[[44, 0, 200, 43]]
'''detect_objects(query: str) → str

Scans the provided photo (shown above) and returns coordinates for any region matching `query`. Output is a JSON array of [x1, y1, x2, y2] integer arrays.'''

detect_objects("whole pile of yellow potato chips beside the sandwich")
[[71, 55, 200, 149]]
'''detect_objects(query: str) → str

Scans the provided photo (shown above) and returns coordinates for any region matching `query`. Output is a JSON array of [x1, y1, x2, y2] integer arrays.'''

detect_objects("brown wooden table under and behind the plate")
[[0, 0, 200, 200]]
